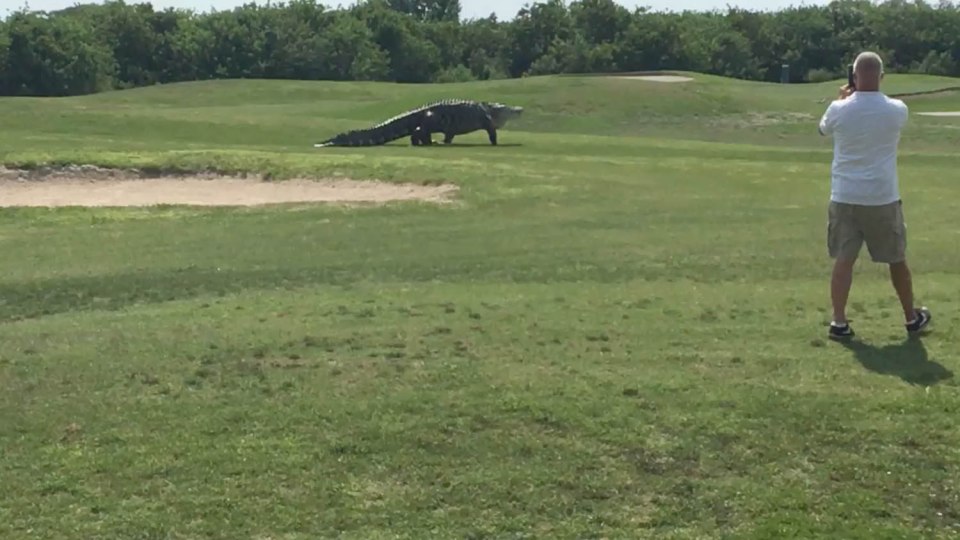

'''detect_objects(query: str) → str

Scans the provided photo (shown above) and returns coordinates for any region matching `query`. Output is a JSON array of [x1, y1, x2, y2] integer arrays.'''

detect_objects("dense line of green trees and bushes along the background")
[[0, 0, 960, 96]]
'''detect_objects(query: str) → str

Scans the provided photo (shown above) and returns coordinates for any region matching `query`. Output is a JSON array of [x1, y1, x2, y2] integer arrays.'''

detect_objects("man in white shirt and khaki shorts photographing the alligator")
[[820, 52, 932, 339]]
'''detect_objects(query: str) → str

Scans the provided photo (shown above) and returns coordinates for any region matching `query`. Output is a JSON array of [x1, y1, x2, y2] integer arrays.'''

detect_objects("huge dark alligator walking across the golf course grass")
[[313, 99, 523, 148]]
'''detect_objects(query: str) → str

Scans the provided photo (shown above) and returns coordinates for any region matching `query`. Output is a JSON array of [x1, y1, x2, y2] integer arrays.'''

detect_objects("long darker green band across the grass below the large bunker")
[[0, 258, 728, 324]]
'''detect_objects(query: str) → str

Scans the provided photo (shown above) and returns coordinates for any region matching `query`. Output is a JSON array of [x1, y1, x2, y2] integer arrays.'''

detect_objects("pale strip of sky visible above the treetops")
[[0, 0, 828, 20]]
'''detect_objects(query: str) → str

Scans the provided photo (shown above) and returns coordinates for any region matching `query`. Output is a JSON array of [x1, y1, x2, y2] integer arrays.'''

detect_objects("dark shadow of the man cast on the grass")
[[841, 337, 953, 386]]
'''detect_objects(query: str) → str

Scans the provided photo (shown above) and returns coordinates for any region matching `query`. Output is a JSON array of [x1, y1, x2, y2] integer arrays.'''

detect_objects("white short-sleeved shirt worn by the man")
[[820, 92, 908, 205]]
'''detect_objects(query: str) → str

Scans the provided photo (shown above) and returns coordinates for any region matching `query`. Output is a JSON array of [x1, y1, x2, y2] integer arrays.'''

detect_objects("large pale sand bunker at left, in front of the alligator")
[[0, 166, 457, 207]]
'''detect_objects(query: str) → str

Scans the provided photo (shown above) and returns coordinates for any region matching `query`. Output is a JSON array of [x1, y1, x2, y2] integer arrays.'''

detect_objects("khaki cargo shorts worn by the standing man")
[[827, 201, 907, 264]]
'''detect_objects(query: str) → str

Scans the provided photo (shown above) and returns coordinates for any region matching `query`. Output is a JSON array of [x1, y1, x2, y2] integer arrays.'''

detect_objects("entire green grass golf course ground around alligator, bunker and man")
[[0, 75, 960, 540]]
